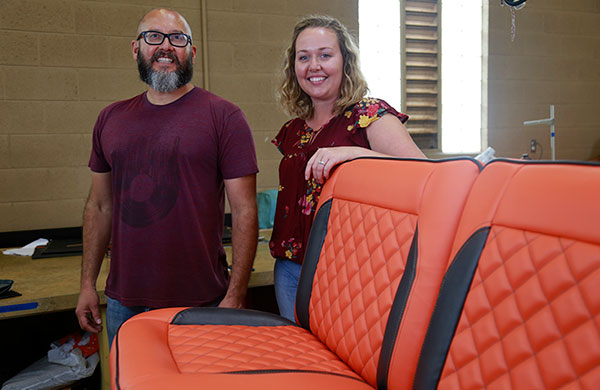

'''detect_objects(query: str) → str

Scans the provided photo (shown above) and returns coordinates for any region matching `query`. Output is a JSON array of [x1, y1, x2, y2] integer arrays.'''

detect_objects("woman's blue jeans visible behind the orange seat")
[[273, 259, 302, 322]]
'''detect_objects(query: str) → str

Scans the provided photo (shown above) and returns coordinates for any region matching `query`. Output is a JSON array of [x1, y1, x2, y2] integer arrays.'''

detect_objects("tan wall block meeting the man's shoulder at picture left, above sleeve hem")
[[44, 101, 107, 135]]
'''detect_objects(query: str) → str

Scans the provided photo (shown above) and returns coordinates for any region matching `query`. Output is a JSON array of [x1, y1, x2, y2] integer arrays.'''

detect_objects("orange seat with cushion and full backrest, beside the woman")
[[111, 158, 481, 390]]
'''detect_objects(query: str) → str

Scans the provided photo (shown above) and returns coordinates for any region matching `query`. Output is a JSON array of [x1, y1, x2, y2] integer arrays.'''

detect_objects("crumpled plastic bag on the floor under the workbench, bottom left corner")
[[2, 332, 100, 390]]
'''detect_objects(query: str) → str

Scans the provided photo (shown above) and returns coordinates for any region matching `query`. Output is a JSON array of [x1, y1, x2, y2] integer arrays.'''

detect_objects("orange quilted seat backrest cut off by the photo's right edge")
[[414, 160, 600, 389]]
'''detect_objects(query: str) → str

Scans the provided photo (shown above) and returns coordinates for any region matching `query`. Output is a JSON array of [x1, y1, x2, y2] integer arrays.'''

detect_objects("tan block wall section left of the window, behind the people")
[[0, 0, 358, 232]]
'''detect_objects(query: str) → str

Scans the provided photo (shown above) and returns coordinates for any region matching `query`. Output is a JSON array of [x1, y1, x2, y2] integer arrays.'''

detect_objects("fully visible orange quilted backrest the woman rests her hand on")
[[296, 158, 481, 389]]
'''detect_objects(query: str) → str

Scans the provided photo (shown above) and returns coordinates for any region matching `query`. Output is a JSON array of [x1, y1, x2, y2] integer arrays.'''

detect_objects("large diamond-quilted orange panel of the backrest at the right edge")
[[440, 226, 600, 389]]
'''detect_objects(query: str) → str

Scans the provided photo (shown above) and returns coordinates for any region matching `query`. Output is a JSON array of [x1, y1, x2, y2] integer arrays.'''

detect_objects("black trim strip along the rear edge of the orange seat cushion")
[[171, 307, 298, 326]]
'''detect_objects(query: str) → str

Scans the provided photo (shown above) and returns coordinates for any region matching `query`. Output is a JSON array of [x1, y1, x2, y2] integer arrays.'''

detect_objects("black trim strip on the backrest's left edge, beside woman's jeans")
[[296, 199, 332, 331]]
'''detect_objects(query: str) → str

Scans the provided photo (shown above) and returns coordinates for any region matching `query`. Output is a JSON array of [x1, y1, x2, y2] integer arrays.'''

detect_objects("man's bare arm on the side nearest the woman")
[[219, 174, 258, 308]]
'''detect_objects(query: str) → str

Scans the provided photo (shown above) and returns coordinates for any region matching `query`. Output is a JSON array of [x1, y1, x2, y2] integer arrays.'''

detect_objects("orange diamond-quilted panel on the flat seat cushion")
[[168, 325, 358, 378]]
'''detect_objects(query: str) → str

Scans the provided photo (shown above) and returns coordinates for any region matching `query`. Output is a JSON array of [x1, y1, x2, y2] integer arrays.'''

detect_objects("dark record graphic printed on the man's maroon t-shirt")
[[115, 136, 179, 228]]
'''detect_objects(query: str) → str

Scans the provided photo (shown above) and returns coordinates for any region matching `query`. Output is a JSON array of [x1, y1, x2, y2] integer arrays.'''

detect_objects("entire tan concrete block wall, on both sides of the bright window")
[[0, 0, 600, 232]]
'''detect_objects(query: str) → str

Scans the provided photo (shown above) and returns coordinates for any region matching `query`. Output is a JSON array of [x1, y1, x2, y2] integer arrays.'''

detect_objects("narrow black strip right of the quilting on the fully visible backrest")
[[377, 227, 419, 390]]
